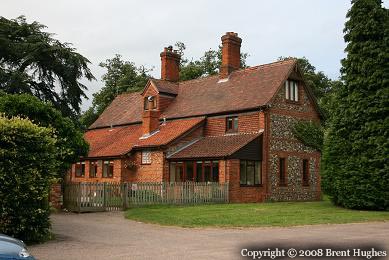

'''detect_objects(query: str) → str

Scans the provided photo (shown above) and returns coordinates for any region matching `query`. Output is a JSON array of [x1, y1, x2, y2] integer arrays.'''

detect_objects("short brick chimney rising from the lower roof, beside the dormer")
[[142, 97, 161, 138]]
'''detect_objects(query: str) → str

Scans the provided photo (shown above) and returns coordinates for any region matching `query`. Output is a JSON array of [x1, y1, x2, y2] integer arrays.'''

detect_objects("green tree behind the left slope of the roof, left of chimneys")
[[80, 54, 151, 128]]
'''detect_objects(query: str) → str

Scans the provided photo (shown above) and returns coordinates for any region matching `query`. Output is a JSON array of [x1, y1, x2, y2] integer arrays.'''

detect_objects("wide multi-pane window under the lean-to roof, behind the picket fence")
[[170, 161, 219, 182]]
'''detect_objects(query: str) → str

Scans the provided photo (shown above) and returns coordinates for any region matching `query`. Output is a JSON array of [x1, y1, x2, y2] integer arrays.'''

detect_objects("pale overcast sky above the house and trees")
[[0, 0, 389, 110]]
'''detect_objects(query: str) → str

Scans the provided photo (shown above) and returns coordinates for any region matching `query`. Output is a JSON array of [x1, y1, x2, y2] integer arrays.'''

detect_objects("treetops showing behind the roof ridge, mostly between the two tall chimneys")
[[175, 42, 248, 81]]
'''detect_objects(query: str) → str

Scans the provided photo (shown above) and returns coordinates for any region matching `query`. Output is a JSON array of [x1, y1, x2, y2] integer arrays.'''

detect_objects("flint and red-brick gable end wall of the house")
[[264, 78, 321, 201]]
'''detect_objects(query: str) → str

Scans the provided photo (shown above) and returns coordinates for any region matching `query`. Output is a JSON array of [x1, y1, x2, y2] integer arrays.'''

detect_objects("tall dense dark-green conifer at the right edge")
[[323, 0, 389, 210]]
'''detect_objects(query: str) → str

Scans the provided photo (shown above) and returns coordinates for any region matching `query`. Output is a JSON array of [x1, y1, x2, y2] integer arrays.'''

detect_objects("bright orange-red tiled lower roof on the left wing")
[[84, 117, 204, 157]]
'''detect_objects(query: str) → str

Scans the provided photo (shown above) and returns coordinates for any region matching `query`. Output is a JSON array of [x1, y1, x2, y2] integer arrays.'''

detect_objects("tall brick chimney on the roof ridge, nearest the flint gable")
[[220, 32, 242, 79]]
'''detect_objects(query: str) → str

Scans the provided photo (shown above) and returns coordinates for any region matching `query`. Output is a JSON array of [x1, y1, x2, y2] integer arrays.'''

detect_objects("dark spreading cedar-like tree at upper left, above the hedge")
[[0, 16, 94, 116]]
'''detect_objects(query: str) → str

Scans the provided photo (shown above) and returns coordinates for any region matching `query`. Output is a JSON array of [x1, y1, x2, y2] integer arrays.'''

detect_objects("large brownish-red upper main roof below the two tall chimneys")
[[90, 59, 296, 129]]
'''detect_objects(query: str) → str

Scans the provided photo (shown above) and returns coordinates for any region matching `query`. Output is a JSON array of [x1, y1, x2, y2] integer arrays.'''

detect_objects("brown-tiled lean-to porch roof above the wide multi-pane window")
[[168, 132, 262, 159]]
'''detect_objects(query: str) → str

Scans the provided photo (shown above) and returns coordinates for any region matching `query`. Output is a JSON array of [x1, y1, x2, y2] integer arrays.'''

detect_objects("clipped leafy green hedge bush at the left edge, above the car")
[[0, 115, 57, 242]]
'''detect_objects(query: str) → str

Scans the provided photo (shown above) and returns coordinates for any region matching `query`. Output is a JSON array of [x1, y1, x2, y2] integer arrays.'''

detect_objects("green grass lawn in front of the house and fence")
[[125, 200, 389, 227]]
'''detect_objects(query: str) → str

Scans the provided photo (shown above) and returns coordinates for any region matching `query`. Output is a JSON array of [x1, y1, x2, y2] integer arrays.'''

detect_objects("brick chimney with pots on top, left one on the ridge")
[[160, 46, 181, 82]]
